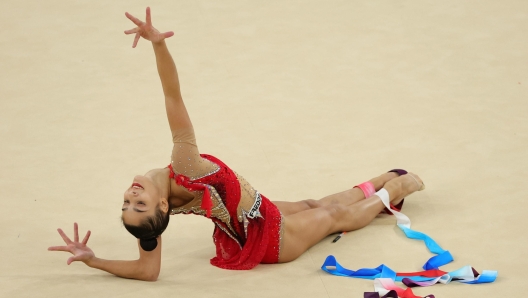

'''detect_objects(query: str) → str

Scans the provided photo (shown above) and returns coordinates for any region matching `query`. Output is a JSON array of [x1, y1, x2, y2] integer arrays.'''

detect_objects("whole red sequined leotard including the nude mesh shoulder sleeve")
[[169, 128, 283, 270]]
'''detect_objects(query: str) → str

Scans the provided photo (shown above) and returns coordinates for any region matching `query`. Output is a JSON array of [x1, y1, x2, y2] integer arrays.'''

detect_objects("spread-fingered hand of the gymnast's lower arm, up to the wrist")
[[48, 223, 95, 265]]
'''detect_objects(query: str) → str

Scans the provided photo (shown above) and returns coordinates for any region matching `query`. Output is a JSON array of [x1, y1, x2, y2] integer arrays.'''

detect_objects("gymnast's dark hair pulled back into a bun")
[[121, 206, 170, 251]]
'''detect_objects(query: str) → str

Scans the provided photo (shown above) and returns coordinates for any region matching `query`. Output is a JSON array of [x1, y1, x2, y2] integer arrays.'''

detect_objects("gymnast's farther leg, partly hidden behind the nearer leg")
[[273, 172, 398, 216]]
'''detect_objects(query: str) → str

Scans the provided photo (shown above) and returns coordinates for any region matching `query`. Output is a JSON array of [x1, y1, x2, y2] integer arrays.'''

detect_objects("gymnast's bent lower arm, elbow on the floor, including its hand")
[[48, 223, 161, 281]]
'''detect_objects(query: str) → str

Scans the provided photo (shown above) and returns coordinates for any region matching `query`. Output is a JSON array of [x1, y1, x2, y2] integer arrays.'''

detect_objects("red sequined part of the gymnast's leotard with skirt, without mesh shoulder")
[[169, 154, 282, 270]]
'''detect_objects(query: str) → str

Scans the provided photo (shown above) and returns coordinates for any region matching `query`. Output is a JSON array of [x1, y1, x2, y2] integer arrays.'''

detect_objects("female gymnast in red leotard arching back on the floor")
[[48, 8, 424, 281]]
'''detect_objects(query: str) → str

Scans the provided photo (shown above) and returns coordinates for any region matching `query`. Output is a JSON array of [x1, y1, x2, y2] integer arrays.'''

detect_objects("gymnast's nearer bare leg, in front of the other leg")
[[279, 173, 423, 263]]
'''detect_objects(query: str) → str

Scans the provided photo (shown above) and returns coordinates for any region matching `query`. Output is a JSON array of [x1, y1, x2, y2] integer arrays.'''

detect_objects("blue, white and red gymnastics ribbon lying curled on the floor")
[[321, 192, 498, 298]]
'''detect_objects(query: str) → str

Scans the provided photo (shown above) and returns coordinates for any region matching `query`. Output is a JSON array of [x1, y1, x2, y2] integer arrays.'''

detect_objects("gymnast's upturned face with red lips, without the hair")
[[122, 175, 161, 225]]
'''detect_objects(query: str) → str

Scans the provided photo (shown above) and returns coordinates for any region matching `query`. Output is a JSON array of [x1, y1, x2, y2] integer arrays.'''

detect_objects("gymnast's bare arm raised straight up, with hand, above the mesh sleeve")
[[125, 7, 192, 132]]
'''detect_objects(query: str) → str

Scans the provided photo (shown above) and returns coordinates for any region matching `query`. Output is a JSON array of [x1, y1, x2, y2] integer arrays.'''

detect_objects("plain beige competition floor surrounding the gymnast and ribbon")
[[0, 0, 528, 298]]
